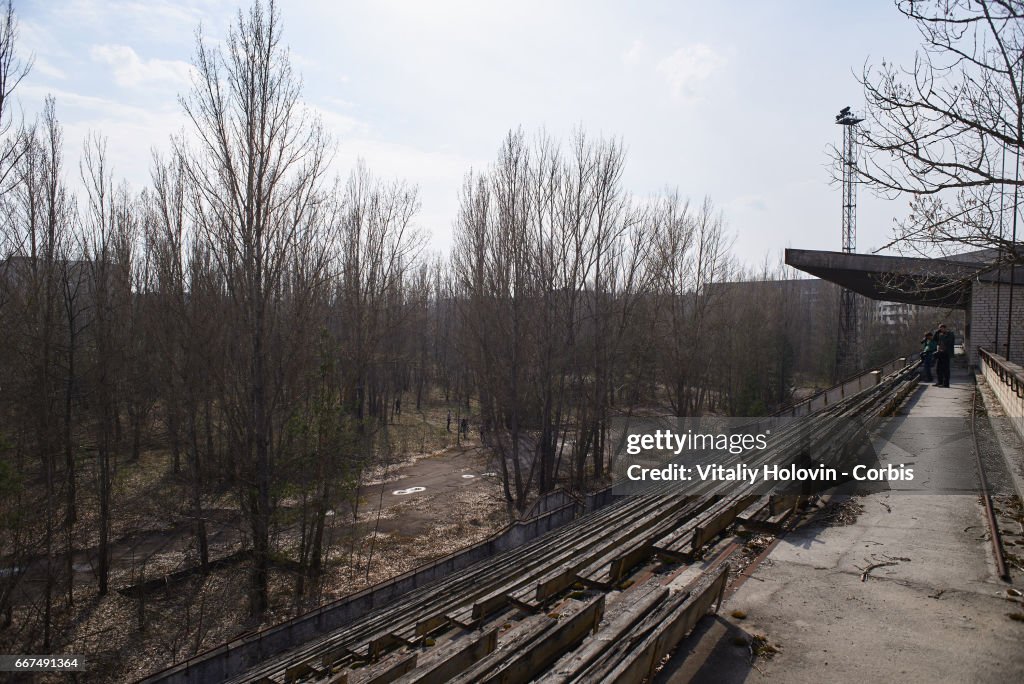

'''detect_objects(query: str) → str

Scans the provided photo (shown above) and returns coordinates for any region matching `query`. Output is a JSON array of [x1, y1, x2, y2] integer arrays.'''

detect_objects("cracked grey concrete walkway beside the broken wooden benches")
[[657, 372, 1024, 684]]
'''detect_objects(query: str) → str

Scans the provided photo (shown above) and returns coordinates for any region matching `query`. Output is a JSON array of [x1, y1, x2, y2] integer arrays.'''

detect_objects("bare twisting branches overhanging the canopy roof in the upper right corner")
[[858, 0, 1024, 266]]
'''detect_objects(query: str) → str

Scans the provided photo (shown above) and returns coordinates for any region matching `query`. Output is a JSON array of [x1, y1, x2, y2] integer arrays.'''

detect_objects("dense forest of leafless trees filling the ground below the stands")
[[0, 2, 921, 671]]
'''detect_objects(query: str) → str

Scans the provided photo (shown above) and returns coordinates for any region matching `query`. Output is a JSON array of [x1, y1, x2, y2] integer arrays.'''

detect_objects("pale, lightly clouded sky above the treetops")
[[8, 0, 920, 266]]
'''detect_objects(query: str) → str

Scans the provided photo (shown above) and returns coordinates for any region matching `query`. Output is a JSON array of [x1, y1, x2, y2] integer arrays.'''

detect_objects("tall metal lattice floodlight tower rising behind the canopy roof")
[[836, 106, 863, 379]]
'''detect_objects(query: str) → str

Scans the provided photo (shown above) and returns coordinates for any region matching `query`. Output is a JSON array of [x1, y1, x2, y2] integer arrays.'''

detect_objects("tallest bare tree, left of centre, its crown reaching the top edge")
[[179, 0, 329, 615]]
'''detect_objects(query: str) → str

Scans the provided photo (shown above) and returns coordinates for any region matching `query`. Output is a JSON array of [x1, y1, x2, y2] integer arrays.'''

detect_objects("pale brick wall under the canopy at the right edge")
[[967, 283, 1024, 367]]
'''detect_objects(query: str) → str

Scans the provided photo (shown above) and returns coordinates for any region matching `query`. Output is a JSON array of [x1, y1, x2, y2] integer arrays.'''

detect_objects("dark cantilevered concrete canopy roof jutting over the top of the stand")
[[785, 249, 985, 308]]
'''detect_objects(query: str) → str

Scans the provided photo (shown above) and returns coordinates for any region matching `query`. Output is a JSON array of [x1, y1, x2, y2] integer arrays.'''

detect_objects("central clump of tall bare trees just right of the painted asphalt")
[[453, 131, 650, 510]]
